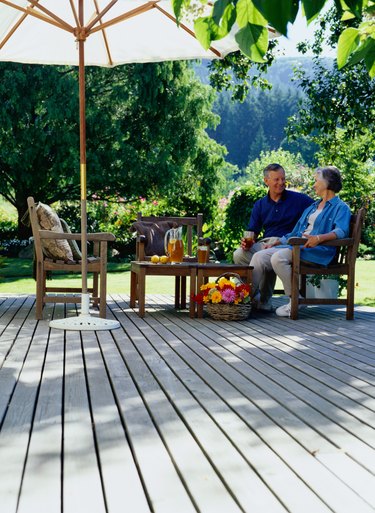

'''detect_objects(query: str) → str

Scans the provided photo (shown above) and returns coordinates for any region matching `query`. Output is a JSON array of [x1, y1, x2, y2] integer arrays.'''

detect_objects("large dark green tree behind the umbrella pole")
[[0, 62, 226, 237]]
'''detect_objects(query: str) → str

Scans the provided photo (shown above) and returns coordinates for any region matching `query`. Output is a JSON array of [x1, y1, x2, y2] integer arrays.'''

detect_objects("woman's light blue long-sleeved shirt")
[[279, 196, 351, 265]]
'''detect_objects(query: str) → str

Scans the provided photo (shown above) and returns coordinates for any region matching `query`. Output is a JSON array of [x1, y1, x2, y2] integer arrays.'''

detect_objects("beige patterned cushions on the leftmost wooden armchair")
[[35, 202, 73, 262]]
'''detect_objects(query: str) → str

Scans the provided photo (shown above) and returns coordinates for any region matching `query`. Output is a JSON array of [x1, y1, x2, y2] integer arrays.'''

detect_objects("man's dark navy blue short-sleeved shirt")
[[247, 190, 314, 237]]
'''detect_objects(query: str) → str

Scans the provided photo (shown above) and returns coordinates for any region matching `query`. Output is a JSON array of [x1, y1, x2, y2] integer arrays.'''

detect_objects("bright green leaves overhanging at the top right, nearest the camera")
[[172, 0, 375, 77]]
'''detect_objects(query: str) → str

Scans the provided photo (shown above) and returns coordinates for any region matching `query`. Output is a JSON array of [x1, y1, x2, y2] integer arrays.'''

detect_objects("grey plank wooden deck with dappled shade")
[[0, 296, 375, 513]]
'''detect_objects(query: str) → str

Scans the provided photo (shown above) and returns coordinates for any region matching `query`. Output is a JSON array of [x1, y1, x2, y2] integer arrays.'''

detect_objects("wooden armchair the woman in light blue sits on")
[[288, 208, 365, 320]]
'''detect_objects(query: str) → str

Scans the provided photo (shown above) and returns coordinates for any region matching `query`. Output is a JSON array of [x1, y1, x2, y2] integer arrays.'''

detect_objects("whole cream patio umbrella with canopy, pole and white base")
[[0, 0, 273, 330]]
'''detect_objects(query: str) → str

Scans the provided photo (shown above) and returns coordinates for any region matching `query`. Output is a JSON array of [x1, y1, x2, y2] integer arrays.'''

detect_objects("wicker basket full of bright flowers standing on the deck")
[[192, 272, 251, 321]]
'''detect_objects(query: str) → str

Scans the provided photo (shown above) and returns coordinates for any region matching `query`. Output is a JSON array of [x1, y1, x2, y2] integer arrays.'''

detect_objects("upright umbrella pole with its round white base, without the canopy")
[[49, 0, 120, 331]]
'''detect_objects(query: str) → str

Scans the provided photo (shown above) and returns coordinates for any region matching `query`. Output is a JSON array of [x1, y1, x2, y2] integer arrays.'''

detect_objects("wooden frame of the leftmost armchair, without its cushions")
[[27, 197, 115, 319]]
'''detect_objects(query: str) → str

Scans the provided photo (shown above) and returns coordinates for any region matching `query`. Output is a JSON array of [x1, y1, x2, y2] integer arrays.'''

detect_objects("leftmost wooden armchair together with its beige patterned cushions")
[[27, 197, 115, 319]]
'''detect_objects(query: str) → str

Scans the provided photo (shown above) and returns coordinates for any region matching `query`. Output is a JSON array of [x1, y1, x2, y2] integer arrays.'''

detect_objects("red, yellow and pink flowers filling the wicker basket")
[[192, 277, 251, 305]]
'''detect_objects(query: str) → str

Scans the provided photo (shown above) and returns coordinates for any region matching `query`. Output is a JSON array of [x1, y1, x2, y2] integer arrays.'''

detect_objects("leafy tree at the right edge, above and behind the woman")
[[287, 9, 375, 208]]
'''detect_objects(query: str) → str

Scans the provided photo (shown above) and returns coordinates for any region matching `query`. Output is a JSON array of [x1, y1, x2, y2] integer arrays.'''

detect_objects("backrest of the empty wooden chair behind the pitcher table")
[[133, 212, 203, 260]]
